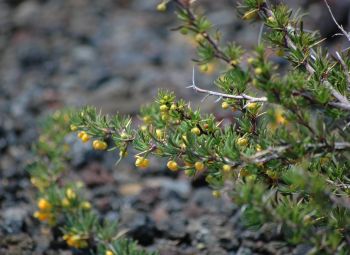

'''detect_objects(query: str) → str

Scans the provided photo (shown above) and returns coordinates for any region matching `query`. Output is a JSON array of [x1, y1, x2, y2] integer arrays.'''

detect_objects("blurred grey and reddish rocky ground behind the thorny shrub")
[[0, 0, 349, 255]]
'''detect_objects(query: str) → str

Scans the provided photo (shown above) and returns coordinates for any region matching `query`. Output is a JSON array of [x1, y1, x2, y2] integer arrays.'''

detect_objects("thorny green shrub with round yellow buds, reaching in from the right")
[[29, 0, 350, 254]]
